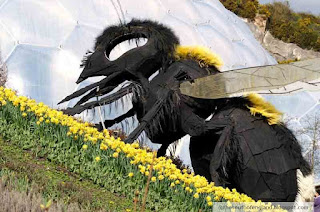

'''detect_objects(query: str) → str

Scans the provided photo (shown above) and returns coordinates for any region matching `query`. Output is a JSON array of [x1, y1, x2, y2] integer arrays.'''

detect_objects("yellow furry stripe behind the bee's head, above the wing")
[[174, 45, 223, 68]]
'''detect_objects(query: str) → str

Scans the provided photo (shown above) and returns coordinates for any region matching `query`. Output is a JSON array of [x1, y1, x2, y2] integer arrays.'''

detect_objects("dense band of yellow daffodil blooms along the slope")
[[0, 87, 276, 210]]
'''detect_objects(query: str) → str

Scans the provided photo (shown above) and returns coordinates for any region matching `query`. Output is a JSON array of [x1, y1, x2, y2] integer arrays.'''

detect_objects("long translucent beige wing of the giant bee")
[[180, 58, 320, 99]]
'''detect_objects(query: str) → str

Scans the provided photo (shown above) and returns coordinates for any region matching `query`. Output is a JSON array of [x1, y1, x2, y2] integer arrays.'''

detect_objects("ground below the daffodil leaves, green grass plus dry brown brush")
[[0, 138, 134, 212]]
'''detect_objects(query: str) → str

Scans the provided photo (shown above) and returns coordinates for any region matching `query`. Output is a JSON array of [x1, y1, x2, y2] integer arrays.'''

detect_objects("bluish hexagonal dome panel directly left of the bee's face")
[[6, 45, 80, 106]]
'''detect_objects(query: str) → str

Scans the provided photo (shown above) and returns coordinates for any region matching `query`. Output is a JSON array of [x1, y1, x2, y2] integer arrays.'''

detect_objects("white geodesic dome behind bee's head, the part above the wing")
[[0, 0, 276, 107]]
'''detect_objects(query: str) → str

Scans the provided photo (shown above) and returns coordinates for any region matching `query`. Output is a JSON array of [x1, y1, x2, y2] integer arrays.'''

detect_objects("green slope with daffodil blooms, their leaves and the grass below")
[[0, 87, 282, 212]]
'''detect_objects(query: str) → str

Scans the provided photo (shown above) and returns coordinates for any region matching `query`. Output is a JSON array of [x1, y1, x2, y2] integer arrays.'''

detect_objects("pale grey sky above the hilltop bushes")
[[259, 0, 320, 15]]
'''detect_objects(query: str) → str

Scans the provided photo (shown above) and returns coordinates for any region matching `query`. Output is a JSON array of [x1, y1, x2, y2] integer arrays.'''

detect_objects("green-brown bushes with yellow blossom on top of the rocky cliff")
[[220, 0, 320, 51]]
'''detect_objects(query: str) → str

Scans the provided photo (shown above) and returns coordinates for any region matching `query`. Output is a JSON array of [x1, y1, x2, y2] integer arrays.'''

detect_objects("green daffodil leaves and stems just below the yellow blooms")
[[0, 97, 211, 212]]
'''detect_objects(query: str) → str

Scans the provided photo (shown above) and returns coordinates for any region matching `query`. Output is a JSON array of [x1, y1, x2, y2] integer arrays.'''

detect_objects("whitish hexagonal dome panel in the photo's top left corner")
[[0, 0, 76, 46]]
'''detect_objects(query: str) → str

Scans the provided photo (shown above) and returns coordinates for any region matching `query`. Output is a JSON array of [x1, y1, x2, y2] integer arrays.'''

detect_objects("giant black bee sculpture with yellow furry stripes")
[[61, 20, 313, 201]]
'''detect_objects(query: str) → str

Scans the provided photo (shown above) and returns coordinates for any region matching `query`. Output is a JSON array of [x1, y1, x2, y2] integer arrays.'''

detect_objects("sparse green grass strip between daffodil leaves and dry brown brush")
[[0, 138, 134, 211]]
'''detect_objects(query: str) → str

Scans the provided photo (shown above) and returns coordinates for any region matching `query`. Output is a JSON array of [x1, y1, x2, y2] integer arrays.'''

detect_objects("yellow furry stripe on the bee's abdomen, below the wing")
[[246, 93, 282, 125]]
